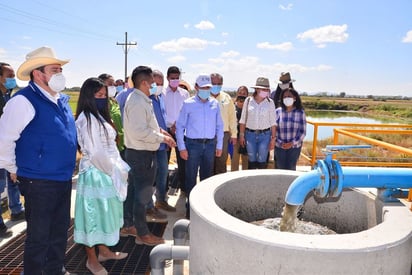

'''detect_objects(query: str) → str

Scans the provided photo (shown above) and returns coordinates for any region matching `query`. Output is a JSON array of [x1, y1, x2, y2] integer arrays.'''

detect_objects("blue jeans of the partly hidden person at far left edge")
[[0, 169, 24, 224]]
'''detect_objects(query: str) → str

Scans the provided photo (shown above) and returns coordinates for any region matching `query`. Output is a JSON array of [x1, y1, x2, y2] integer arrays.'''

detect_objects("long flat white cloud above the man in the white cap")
[[152, 37, 222, 52]]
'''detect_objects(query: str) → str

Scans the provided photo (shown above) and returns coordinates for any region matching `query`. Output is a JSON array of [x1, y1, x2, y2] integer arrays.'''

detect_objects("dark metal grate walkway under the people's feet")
[[0, 220, 167, 275]]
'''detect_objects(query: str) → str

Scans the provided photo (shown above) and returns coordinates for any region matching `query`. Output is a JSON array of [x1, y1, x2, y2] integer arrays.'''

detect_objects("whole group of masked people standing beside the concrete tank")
[[0, 47, 306, 275]]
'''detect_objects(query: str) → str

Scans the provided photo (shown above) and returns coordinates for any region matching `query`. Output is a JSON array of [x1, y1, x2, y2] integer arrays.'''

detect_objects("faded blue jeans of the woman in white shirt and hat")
[[245, 130, 272, 163]]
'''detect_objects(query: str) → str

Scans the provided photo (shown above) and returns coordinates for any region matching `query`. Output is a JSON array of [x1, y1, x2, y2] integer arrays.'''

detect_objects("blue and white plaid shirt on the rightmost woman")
[[275, 107, 306, 148]]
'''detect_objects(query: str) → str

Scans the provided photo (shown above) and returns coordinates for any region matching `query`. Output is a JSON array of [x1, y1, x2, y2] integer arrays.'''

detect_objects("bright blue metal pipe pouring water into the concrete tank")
[[285, 165, 412, 205]]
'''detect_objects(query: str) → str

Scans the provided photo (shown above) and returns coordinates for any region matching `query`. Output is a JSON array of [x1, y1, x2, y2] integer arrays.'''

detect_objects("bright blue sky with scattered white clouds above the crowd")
[[0, 0, 412, 96]]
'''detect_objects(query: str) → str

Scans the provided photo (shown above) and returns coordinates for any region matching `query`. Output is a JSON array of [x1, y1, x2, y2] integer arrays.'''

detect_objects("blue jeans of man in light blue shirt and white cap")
[[185, 138, 216, 197]]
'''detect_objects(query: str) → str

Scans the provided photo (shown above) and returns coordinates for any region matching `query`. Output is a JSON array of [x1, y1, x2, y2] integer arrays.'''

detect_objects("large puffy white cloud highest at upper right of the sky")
[[297, 24, 349, 48]]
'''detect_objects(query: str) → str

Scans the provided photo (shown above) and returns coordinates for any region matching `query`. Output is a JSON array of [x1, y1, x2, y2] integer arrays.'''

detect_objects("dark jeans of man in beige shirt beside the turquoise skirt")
[[123, 148, 157, 236]]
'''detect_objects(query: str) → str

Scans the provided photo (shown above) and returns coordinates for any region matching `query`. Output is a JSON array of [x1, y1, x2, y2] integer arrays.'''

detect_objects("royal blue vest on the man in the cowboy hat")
[[15, 81, 77, 181]]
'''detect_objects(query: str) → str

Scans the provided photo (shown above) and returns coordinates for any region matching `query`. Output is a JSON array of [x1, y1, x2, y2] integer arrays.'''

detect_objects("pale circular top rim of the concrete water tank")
[[190, 169, 412, 251]]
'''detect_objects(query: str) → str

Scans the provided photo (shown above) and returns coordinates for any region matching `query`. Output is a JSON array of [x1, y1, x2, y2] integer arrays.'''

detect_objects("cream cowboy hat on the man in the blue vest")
[[17, 47, 69, 81]]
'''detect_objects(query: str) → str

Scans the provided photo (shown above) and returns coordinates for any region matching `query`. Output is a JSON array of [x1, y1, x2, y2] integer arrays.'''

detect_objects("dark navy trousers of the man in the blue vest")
[[18, 177, 72, 275]]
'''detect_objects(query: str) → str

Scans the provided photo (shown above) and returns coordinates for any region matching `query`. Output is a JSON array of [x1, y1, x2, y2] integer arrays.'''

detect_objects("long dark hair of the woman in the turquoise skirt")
[[75, 77, 112, 141]]
